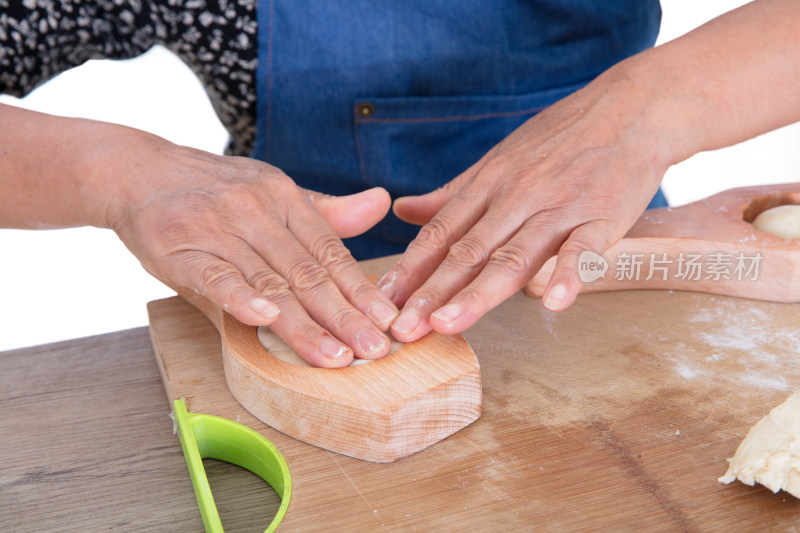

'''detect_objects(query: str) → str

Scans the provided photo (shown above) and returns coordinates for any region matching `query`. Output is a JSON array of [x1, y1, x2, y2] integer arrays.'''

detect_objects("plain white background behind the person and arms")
[[0, 0, 800, 350]]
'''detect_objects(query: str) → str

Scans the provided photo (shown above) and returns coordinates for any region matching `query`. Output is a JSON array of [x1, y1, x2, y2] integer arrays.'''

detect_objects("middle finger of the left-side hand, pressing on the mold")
[[254, 220, 391, 359]]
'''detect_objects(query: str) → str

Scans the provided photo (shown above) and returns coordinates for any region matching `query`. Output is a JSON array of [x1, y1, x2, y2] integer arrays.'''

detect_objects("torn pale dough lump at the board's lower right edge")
[[719, 391, 800, 498]]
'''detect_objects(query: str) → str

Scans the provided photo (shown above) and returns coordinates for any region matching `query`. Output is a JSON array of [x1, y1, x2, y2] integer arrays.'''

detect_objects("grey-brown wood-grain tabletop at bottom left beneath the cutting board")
[[0, 328, 279, 533]]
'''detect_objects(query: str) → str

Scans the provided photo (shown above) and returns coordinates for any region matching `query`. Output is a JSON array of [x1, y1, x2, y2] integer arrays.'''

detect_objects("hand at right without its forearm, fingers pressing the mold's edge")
[[379, 61, 670, 342]]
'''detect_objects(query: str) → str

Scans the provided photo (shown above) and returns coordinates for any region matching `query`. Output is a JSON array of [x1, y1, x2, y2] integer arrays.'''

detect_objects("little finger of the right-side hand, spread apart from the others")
[[542, 220, 622, 311]]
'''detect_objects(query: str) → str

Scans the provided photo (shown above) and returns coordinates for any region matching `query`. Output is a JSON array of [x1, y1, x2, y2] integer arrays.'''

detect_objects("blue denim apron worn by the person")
[[252, 0, 666, 259]]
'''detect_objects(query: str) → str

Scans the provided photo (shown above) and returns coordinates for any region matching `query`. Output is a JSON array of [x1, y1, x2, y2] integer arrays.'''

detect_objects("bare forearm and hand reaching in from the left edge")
[[0, 105, 397, 367]]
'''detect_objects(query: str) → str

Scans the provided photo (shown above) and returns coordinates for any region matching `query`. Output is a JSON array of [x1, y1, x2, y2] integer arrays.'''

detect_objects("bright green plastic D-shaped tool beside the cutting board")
[[173, 398, 292, 533]]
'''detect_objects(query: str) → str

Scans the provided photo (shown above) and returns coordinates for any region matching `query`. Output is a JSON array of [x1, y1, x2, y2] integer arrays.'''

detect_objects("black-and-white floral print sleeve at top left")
[[0, 0, 258, 155]]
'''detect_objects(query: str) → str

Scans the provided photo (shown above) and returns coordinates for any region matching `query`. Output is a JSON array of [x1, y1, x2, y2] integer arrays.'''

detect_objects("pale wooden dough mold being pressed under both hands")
[[168, 280, 481, 463]]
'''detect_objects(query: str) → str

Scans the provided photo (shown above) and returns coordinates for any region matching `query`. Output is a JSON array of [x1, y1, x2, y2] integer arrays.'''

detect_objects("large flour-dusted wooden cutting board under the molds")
[[151, 258, 800, 531]]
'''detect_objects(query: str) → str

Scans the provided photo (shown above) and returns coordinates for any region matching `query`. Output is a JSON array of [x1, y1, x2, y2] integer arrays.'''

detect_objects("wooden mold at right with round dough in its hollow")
[[525, 183, 800, 302]]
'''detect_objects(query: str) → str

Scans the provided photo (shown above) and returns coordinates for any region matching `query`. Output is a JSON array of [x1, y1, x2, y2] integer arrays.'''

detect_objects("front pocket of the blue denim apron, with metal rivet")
[[353, 84, 583, 244]]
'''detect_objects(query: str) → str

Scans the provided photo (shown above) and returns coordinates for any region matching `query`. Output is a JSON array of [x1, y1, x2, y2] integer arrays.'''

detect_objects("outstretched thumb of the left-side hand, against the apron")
[[306, 187, 392, 239]]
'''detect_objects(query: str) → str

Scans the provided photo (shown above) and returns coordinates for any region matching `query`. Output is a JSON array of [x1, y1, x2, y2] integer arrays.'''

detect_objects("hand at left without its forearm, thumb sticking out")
[[101, 126, 397, 367]]
